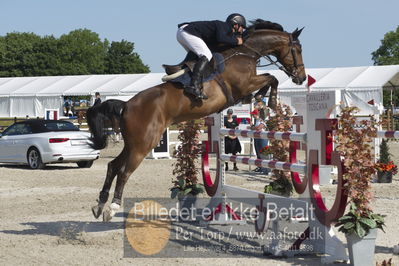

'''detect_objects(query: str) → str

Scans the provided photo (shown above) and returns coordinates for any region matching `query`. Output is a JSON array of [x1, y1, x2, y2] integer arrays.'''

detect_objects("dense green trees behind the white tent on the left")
[[0, 29, 149, 77]]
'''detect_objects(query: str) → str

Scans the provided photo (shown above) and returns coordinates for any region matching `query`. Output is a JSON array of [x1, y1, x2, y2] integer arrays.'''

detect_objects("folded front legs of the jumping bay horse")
[[250, 73, 278, 110]]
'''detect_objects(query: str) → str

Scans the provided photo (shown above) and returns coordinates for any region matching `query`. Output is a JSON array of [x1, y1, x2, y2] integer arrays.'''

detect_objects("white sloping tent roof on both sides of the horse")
[[0, 65, 399, 97]]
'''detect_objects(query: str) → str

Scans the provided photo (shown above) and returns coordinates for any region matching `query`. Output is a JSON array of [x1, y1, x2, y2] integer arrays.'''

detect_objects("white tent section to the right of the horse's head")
[[262, 65, 399, 115]]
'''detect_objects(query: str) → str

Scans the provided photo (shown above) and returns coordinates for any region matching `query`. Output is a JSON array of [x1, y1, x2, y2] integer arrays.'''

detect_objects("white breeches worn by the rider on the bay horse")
[[176, 25, 212, 61]]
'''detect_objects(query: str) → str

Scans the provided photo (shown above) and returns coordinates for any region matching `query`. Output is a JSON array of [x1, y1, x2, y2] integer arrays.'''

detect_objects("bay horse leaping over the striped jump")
[[88, 19, 306, 221]]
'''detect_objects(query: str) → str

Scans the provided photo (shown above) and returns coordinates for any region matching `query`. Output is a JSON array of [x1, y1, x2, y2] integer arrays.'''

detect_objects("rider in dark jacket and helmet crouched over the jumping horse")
[[176, 13, 246, 99]]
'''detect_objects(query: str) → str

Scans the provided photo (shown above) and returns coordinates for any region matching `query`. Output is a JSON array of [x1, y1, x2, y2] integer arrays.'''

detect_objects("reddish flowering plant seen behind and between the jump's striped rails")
[[261, 103, 293, 197]]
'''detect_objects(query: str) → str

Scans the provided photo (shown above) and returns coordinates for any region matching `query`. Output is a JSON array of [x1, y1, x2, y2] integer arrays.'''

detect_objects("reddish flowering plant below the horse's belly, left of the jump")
[[170, 120, 204, 207]]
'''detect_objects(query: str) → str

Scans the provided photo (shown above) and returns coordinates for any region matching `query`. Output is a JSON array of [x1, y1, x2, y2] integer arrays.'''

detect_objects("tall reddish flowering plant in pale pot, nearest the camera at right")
[[335, 107, 384, 265]]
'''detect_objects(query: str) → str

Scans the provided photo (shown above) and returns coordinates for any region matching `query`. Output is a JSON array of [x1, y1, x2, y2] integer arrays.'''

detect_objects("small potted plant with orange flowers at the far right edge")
[[375, 139, 398, 183]]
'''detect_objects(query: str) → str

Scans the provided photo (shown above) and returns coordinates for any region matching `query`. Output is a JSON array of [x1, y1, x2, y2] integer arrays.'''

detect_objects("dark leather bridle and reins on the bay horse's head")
[[243, 33, 304, 79]]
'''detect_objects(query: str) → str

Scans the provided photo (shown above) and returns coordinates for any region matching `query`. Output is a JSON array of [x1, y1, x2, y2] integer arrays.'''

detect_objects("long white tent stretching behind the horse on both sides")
[[0, 65, 399, 117]]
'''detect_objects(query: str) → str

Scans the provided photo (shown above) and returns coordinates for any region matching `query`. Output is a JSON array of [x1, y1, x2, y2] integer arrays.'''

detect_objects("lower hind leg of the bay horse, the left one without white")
[[91, 149, 126, 219]]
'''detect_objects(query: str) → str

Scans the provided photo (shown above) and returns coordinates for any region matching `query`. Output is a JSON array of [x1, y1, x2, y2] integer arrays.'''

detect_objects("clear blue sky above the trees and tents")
[[0, 0, 399, 73]]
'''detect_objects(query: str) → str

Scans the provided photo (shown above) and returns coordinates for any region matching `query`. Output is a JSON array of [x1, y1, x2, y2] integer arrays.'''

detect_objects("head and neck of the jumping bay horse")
[[244, 19, 306, 85]]
